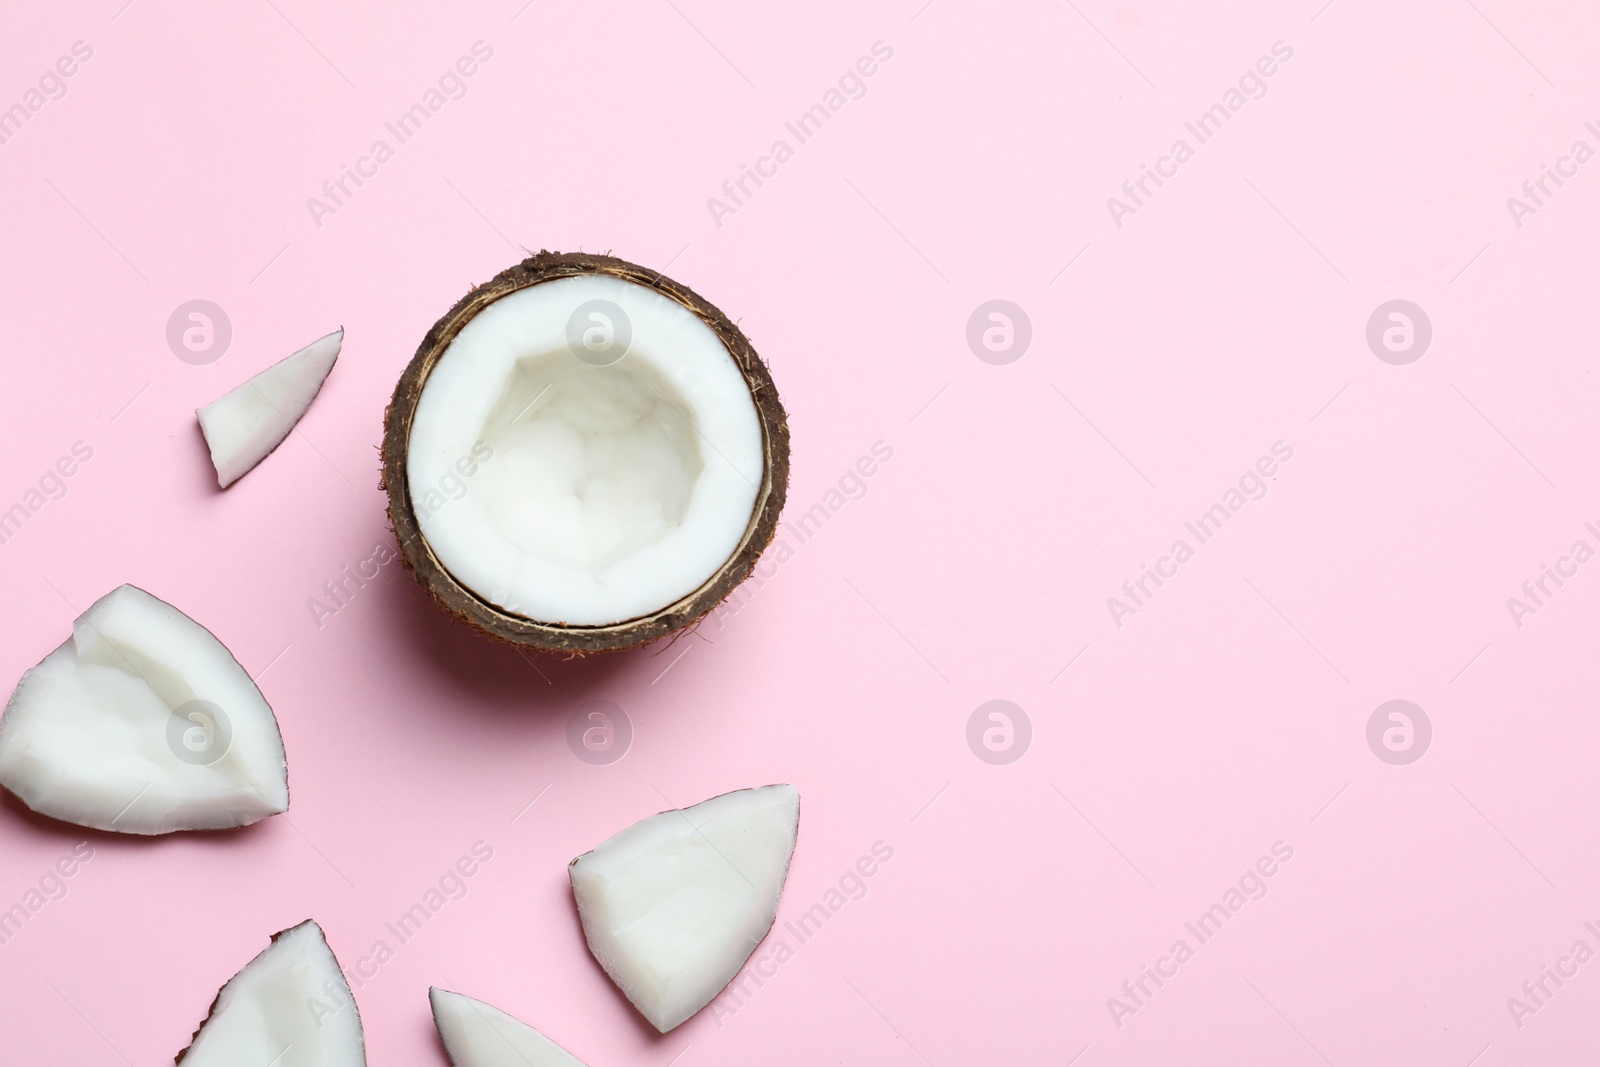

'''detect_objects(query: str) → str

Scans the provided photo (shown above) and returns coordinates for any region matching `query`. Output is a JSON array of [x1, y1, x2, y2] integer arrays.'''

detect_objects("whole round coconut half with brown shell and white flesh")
[[384, 253, 789, 653]]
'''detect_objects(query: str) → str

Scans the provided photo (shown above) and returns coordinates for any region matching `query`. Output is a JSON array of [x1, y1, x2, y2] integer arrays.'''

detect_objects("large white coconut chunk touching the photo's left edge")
[[0, 585, 290, 833]]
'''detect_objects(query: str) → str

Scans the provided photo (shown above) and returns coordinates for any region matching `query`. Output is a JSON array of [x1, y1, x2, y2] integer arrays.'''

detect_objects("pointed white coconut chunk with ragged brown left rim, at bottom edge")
[[178, 920, 366, 1067]]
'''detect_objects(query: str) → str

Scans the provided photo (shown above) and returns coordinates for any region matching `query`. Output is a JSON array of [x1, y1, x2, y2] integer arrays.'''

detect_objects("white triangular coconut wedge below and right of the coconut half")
[[568, 785, 800, 1033]]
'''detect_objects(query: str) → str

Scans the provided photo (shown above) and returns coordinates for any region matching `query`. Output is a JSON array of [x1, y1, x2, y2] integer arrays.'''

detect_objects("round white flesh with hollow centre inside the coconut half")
[[406, 274, 763, 625]]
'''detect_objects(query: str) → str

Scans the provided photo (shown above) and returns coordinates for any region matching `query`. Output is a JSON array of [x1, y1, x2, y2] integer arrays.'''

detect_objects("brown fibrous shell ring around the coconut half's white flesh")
[[382, 251, 789, 656]]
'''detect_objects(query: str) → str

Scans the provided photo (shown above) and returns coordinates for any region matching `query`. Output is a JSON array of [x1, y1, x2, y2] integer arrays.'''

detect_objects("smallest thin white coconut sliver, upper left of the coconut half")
[[195, 326, 344, 490]]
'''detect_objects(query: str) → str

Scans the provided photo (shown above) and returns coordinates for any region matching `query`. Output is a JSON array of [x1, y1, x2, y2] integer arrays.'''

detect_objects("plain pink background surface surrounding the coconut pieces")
[[0, 0, 1600, 1067]]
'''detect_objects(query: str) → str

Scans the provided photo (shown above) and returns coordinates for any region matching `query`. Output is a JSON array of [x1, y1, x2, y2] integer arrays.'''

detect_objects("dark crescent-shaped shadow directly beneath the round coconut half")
[[374, 569, 670, 715]]
